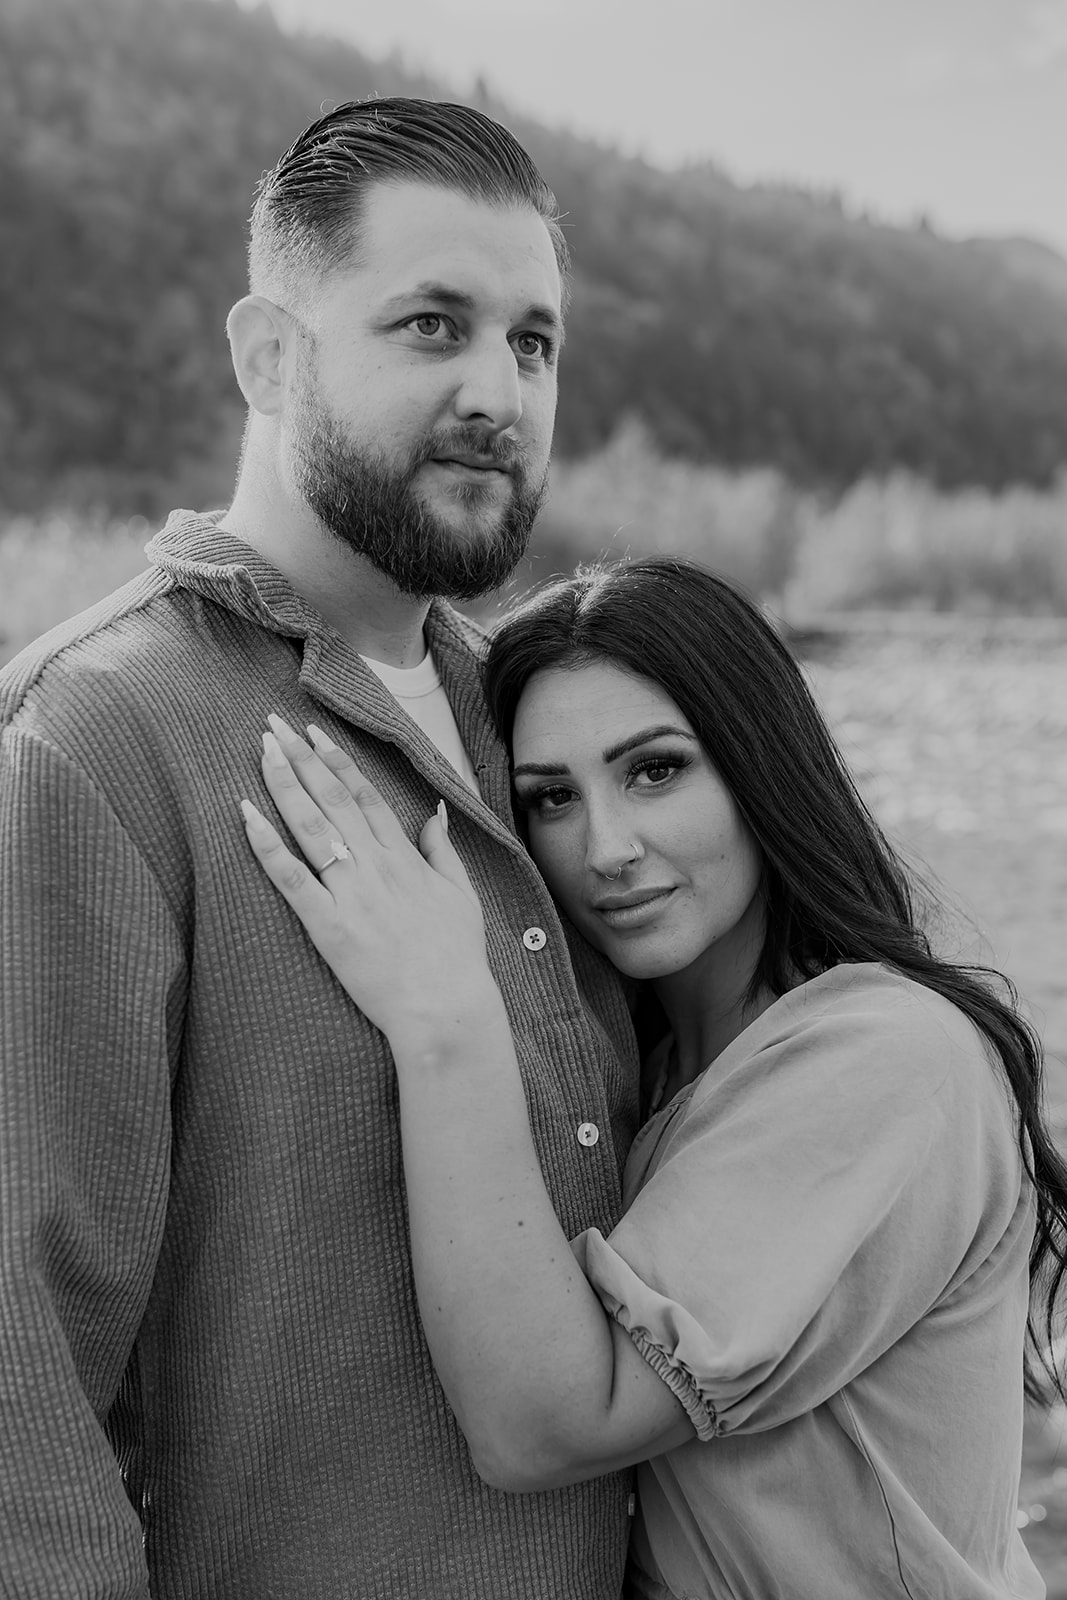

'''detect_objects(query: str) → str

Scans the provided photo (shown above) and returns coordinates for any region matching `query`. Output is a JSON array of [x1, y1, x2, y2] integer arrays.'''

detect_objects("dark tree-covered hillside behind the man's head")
[[0, 0, 1067, 510]]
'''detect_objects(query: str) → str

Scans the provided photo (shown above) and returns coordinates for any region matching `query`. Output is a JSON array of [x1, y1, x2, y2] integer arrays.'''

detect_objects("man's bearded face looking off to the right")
[[286, 182, 561, 598]]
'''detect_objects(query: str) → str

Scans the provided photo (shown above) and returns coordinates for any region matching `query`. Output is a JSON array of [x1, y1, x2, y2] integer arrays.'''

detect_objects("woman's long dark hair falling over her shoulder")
[[485, 558, 1067, 1398]]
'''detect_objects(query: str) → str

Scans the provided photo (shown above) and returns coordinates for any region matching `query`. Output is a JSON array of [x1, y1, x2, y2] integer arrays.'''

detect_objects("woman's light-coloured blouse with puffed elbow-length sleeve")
[[574, 965, 1045, 1600]]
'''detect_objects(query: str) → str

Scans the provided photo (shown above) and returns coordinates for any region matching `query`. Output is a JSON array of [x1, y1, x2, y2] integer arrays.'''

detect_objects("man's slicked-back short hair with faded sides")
[[248, 96, 569, 309]]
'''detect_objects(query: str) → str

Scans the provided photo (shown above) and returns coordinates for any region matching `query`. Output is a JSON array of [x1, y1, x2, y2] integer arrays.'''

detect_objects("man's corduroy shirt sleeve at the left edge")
[[0, 726, 184, 1600]]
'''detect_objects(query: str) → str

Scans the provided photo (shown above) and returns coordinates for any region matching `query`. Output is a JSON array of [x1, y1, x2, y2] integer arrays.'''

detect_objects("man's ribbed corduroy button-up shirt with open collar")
[[0, 512, 637, 1600]]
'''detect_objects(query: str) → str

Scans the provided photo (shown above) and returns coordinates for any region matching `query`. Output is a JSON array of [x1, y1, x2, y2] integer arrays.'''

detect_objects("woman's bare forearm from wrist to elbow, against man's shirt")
[[397, 994, 614, 1486]]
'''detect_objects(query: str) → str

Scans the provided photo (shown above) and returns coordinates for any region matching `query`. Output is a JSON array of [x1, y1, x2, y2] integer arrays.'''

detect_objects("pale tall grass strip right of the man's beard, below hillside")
[[536, 422, 1067, 616]]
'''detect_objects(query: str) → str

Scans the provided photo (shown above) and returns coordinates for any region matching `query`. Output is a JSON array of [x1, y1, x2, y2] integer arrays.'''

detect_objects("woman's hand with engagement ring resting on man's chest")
[[242, 717, 501, 1058]]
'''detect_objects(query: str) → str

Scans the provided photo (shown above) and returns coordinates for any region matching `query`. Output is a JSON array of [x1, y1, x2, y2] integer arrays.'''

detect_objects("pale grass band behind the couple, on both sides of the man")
[[0, 438, 1067, 659]]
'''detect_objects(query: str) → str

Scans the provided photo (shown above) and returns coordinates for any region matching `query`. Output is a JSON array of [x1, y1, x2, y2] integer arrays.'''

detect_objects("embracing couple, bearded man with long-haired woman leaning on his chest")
[[0, 99, 1067, 1600]]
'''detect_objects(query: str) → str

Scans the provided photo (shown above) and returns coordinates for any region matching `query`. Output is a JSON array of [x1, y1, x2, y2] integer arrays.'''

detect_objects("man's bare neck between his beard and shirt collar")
[[221, 485, 429, 667]]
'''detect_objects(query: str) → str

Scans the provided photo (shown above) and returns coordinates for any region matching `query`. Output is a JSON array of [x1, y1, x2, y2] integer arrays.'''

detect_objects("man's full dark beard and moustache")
[[293, 384, 547, 600]]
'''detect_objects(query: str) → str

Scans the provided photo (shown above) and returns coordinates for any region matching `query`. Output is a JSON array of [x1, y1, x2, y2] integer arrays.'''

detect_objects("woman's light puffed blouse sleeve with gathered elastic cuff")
[[574, 968, 1030, 1440]]
